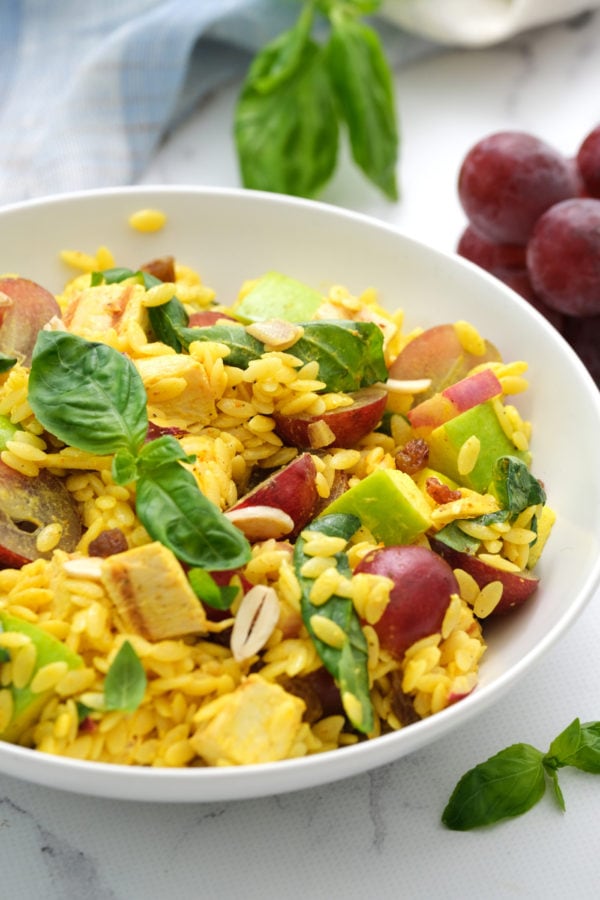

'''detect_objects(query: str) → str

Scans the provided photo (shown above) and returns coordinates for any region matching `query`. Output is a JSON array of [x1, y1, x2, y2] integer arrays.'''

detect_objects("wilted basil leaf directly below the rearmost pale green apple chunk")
[[289, 320, 388, 392]]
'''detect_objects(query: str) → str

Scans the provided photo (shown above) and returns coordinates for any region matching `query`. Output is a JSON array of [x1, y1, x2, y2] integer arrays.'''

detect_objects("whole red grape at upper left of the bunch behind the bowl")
[[458, 131, 578, 244]]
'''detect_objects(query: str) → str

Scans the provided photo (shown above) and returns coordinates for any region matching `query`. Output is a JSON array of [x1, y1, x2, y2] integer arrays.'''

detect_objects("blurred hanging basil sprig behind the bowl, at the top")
[[234, 0, 399, 200]]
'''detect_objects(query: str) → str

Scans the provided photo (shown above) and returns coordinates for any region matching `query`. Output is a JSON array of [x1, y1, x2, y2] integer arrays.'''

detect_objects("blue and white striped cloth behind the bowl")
[[0, 0, 433, 204]]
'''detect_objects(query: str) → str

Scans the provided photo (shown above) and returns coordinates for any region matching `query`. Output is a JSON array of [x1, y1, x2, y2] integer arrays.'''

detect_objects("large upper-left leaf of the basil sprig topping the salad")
[[28, 331, 148, 454]]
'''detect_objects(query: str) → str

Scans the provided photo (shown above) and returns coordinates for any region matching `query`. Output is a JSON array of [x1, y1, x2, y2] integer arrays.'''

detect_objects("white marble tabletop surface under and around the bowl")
[[0, 12, 600, 900]]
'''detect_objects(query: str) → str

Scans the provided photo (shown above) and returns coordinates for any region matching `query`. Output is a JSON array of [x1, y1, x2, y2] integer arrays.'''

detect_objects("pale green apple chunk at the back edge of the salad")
[[233, 272, 323, 323]]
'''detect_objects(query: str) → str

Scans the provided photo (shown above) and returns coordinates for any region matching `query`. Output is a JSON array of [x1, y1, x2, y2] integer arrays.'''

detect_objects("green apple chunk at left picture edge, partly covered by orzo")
[[0, 612, 83, 742]]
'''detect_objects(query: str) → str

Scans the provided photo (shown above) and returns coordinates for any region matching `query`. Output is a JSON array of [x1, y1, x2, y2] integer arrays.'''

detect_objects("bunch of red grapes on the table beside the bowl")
[[457, 125, 600, 386]]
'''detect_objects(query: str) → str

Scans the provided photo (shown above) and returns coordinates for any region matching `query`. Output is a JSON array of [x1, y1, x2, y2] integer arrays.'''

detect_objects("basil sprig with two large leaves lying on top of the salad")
[[29, 331, 250, 570]]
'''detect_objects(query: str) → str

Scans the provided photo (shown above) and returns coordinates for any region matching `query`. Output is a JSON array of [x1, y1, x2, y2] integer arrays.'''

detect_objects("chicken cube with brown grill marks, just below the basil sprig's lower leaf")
[[101, 541, 206, 641]]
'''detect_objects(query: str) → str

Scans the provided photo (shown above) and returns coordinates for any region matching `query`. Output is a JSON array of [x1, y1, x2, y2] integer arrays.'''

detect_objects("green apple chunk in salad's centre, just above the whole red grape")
[[323, 469, 431, 546]]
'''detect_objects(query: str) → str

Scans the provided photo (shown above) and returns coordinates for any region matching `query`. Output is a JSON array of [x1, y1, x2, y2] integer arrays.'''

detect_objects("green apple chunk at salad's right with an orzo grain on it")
[[427, 401, 530, 492]]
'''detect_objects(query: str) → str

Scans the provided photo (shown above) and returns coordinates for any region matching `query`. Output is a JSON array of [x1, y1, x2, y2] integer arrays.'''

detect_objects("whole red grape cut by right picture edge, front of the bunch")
[[527, 197, 600, 316]]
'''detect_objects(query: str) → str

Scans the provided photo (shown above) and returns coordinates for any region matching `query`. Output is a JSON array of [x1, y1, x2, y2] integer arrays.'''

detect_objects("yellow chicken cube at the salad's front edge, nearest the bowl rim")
[[191, 675, 305, 766]]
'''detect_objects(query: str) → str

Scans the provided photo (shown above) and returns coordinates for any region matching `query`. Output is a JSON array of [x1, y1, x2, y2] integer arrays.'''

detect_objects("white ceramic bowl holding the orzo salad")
[[0, 187, 600, 802]]
